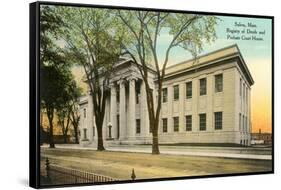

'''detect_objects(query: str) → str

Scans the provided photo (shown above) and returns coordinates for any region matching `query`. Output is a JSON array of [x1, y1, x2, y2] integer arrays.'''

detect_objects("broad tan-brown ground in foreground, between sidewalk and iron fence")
[[41, 148, 272, 180]]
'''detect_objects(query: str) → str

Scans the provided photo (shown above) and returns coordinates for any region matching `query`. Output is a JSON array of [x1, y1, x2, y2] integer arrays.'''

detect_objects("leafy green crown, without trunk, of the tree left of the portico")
[[56, 7, 122, 80]]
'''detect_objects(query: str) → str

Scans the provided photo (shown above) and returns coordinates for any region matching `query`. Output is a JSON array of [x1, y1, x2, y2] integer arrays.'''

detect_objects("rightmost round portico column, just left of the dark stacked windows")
[[128, 78, 136, 138]]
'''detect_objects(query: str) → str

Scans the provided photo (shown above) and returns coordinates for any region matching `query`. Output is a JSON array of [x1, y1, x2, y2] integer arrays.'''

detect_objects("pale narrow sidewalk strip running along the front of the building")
[[41, 144, 272, 160]]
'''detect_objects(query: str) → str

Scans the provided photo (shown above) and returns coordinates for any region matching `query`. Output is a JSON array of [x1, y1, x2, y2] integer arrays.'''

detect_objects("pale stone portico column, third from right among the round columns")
[[110, 84, 117, 139]]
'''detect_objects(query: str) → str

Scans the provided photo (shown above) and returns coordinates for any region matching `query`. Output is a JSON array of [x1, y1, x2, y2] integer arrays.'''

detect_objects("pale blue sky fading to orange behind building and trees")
[[73, 11, 272, 132]]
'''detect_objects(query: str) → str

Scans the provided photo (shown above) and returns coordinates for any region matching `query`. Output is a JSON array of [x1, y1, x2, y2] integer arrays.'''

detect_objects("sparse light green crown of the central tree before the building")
[[117, 10, 218, 67]]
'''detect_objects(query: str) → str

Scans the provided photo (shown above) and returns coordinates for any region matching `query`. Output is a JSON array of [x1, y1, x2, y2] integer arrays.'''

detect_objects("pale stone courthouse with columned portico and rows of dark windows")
[[77, 45, 254, 146]]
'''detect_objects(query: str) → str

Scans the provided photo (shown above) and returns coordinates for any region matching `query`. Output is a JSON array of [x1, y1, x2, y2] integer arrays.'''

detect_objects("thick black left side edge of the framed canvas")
[[29, 2, 40, 188]]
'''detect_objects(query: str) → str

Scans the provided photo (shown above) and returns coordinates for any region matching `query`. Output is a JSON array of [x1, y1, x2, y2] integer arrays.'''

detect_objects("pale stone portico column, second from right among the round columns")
[[119, 80, 126, 140]]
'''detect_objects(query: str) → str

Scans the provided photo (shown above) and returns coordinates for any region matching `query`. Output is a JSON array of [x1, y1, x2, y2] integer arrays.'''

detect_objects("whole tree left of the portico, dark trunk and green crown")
[[55, 6, 128, 150]]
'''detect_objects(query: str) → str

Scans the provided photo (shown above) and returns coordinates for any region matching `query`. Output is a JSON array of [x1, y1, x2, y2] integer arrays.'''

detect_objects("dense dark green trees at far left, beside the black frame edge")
[[40, 6, 81, 147]]
